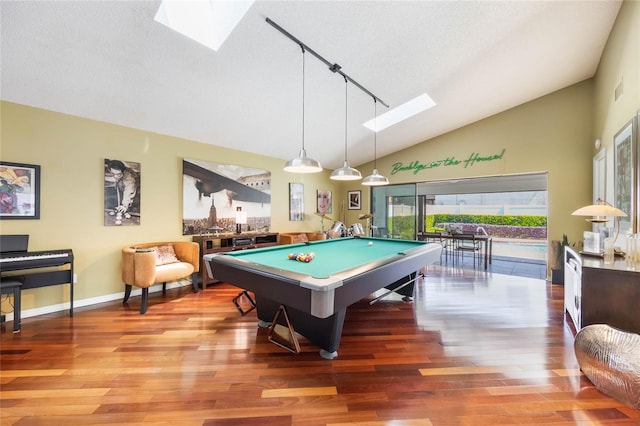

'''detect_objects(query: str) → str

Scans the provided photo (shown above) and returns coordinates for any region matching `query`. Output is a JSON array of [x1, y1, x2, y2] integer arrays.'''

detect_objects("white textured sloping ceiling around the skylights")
[[0, 0, 621, 171]]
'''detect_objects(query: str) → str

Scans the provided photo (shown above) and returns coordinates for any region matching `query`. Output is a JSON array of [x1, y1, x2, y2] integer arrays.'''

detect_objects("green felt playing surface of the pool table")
[[227, 238, 424, 278]]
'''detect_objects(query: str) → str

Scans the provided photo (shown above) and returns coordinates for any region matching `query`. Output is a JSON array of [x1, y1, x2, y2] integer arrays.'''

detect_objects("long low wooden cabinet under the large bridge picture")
[[193, 233, 278, 289]]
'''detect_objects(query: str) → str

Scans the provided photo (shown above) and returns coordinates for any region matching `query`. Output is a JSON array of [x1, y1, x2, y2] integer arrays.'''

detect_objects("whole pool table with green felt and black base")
[[204, 237, 442, 359]]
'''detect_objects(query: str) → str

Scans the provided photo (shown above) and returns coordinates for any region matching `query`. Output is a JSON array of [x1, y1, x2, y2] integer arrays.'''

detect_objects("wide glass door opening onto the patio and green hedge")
[[371, 173, 548, 259]]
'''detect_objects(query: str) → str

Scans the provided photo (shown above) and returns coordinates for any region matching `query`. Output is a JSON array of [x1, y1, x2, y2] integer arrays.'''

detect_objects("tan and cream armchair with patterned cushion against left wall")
[[122, 241, 200, 314]]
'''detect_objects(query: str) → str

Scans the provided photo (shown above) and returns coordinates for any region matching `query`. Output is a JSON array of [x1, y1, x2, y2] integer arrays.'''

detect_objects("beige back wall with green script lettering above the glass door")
[[349, 80, 593, 245]]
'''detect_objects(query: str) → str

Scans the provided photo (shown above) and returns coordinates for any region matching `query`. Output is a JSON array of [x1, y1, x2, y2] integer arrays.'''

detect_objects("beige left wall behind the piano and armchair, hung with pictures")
[[0, 102, 338, 316]]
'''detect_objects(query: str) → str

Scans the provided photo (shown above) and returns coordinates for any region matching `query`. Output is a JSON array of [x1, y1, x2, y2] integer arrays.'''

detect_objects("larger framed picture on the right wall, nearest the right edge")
[[613, 120, 638, 235]]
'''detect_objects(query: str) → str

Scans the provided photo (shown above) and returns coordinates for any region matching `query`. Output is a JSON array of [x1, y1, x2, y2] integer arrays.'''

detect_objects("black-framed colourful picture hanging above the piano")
[[0, 161, 40, 219]]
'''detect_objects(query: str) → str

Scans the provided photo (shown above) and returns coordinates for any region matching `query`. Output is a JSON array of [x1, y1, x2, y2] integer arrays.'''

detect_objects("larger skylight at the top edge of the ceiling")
[[154, 0, 253, 51]]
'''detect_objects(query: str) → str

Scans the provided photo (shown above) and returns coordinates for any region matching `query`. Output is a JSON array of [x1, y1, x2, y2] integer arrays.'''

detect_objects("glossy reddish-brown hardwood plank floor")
[[0, 266, 640, 426]]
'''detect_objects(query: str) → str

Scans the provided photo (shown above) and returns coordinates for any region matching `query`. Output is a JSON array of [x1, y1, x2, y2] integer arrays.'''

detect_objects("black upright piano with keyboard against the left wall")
[[0, 235, 73, 317]]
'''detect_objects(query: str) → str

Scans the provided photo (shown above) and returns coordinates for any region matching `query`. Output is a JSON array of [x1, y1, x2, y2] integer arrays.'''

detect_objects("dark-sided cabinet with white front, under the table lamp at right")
[[564, 247, 640, 334]]
